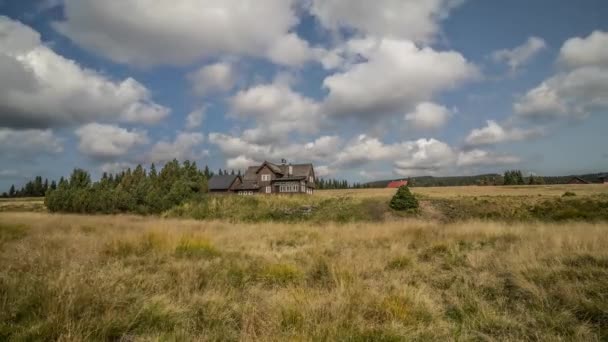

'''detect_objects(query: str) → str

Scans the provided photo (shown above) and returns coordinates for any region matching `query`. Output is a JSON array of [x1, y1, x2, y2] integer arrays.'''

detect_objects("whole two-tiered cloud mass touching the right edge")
[[514, 31, 608, 119]]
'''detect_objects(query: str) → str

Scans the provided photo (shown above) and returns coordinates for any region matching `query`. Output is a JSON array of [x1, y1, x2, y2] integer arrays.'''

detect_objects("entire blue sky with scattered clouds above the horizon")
[[0, 0, 608, 189]]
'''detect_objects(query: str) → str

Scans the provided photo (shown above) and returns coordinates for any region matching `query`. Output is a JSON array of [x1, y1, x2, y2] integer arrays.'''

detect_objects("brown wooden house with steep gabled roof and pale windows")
[[234, 161, 315, 195]]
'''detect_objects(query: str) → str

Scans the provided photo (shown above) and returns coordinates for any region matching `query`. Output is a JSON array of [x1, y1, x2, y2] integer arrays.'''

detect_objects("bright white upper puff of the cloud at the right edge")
[[559, 31, 608, 68]]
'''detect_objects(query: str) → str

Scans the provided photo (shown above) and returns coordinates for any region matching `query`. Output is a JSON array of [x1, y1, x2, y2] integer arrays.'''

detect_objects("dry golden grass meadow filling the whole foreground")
[[0, 212, 608, 341]]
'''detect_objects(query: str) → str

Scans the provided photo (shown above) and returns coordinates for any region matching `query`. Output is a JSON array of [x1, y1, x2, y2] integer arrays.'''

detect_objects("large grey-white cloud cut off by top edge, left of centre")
[[55, 0, 312, 66]]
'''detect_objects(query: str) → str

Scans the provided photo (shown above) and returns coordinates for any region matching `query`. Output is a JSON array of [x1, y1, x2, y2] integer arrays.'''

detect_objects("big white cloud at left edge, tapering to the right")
[[0, 16, 169, 128]]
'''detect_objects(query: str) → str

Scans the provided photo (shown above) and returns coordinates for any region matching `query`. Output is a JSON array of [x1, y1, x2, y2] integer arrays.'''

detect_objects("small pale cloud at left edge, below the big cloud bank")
[[0, 127, 63, 158]]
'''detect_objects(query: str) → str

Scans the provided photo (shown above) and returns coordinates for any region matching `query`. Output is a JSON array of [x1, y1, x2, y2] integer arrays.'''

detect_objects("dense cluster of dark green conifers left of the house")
[[45, 160, 212, 214]]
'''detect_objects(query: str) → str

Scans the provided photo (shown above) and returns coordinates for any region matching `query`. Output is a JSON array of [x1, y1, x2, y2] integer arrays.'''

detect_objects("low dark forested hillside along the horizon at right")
[[364, 172, 606, 188]]
